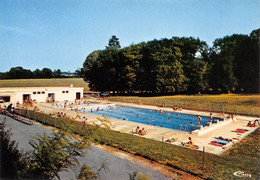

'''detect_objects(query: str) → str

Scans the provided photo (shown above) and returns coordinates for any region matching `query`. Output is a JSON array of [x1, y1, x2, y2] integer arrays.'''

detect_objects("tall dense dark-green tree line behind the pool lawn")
[[80, 29, 260, 94]]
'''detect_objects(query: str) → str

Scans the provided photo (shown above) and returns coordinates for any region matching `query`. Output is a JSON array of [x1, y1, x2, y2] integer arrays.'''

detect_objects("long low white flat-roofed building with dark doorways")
[[0, 86, 84, 104]]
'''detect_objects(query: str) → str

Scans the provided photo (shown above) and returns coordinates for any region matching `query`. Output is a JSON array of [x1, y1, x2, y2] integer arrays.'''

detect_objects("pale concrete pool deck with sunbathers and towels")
[[37, 102, 257, 155]]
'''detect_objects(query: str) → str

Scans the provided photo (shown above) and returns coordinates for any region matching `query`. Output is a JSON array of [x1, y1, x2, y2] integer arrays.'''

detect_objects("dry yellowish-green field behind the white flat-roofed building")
[[0, 78, 90, 92]]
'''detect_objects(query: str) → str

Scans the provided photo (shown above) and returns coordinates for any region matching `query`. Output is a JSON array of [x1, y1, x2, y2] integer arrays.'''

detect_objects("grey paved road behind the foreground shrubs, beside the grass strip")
[[0, 115, 171, 180]]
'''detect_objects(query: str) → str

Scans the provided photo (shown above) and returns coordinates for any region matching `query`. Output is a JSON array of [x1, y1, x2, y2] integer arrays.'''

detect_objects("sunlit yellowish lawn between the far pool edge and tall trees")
[[106, 94, 260, 117]]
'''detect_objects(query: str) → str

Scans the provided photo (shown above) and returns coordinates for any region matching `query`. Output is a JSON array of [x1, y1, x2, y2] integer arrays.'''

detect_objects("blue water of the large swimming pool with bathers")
[[82, 106, 223, 132]]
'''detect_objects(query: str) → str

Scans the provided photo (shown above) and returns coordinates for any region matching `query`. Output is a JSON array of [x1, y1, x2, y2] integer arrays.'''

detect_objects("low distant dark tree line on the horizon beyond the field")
[[0, 66, 70, 79]]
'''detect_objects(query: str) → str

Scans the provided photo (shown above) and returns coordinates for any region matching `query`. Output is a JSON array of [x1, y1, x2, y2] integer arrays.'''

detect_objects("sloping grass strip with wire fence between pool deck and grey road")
[[17, 109, 258, 179]]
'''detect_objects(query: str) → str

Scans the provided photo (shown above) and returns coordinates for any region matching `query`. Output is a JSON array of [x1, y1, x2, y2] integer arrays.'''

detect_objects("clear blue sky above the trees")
[[0, 0, 260, 72]]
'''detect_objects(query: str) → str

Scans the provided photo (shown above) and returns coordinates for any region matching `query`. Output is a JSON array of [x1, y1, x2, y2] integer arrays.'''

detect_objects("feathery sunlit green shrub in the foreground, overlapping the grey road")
[[24, 122, 89, 179]]
